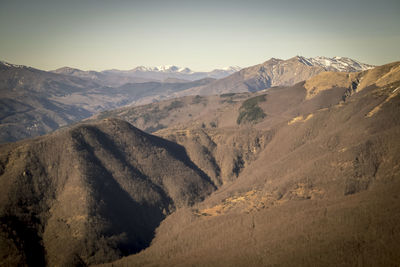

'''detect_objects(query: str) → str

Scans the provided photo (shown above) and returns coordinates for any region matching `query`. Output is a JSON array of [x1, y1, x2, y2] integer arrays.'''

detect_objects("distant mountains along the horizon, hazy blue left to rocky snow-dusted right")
[[0, 57, 372, 143]]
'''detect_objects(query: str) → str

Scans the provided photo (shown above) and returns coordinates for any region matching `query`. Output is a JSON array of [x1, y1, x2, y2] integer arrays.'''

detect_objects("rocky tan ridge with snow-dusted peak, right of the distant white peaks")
[[173, 56, 374, 96]]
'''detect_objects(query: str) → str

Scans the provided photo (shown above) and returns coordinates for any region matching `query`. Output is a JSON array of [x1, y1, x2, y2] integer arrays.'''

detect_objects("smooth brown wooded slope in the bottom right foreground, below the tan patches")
[[106, 184, 400, 266]]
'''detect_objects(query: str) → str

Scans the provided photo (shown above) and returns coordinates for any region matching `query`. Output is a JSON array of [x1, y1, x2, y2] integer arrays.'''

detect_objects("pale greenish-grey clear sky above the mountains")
[[0, 0, 400, 71]]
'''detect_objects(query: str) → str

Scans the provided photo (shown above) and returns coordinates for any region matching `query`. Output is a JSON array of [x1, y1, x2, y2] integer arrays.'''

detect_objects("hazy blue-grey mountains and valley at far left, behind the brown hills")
[[0, 62, 213, 143]]
